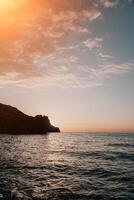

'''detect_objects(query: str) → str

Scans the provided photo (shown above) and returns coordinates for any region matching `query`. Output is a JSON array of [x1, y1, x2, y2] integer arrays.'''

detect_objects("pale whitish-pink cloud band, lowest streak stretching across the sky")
[[0, 57, 134, 88]]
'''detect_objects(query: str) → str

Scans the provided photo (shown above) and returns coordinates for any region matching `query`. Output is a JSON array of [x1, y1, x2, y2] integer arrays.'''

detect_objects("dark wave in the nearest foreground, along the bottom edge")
[[1, 188, 118, 200]]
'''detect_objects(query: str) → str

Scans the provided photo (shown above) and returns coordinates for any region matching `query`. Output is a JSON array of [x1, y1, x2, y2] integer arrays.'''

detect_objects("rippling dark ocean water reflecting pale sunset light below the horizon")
[[0, 133, 134, 200]]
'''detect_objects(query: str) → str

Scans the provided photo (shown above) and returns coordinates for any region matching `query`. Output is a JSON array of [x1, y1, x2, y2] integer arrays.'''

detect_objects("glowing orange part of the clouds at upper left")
[[0, 0, 101, 77]]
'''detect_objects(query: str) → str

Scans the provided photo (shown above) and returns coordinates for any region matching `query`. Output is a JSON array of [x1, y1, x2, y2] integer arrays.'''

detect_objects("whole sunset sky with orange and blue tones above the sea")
[[0, 0, 134, 132]]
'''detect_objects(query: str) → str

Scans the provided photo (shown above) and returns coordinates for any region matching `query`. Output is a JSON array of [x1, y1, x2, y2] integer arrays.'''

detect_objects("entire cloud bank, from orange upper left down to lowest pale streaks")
[[0, 0, 133, 88]]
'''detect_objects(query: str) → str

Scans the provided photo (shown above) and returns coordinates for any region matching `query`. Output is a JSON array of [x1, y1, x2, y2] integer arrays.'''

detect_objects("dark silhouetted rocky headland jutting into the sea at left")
[[0, 103, 60, 135]]
